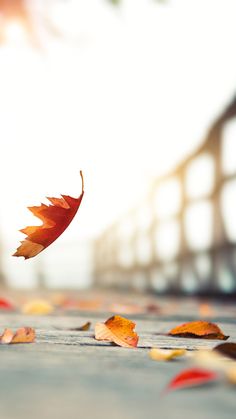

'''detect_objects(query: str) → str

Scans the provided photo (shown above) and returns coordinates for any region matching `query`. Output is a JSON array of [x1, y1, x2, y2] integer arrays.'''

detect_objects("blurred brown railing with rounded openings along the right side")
[[94, 95, 236, 294]]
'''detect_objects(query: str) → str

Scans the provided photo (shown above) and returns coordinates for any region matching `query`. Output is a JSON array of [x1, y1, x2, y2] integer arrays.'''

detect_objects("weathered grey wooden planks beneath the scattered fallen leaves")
[[0, 307, 236, 419]]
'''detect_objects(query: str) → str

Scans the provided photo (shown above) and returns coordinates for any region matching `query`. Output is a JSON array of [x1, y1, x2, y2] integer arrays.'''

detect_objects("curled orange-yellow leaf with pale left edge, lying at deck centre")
[[95, 316, 139, 348]]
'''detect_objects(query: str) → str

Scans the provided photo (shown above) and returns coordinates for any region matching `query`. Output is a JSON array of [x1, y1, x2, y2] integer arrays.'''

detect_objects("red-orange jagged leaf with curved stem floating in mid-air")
[[13, 172, 84, 259]]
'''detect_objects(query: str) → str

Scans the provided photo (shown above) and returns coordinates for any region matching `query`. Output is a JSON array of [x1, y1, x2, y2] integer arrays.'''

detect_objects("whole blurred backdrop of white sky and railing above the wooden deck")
[[0, 0, 236, 295]]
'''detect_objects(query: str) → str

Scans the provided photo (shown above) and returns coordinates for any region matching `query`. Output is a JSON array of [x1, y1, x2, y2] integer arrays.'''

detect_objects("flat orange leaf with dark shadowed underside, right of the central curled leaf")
[[168, 320, 229, 340]]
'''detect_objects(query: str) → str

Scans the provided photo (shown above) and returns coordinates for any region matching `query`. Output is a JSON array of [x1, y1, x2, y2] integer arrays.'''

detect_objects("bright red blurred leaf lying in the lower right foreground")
[[166, 368, 219, 391]]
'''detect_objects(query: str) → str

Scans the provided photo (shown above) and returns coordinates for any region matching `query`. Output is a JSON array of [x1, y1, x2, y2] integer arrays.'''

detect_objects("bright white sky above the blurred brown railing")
[[0, 0, 236, 288]]
